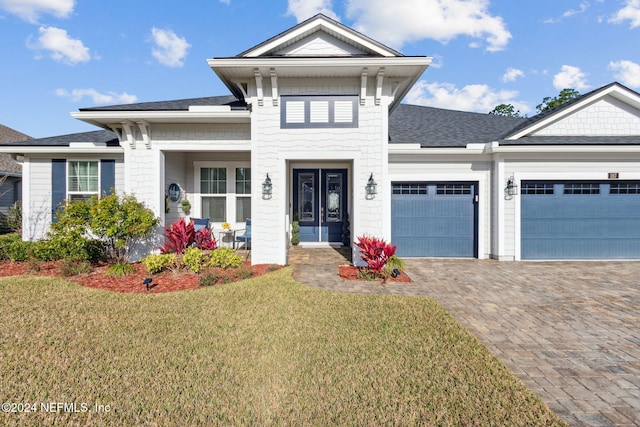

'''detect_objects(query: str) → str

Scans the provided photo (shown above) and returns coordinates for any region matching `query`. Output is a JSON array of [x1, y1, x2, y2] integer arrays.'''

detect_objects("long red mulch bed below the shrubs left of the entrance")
[[0, 261, 280, 293]]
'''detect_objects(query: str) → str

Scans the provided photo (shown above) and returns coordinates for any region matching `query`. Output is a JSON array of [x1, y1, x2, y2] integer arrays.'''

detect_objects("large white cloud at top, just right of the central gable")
[[344, 0, 511, 51]]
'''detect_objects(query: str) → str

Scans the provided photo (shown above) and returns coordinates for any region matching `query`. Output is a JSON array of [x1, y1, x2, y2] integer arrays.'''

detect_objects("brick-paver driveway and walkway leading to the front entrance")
[[290, 249, 640, 426]]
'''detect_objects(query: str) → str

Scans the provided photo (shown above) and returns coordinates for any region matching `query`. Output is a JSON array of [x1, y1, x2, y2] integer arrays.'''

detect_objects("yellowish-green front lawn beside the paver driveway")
[[0, 268, 563, 426]]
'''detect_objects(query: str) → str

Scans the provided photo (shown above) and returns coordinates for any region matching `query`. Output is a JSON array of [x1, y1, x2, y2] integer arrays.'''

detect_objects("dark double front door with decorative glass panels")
[[293, 169, 347, 242]]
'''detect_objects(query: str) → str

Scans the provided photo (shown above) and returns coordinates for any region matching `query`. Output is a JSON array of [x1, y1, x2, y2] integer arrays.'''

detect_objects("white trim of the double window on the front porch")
[[191, 161, 254, 229]]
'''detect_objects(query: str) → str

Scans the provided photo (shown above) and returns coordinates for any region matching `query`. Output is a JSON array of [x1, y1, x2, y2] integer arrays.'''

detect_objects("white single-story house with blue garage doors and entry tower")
[[0, 15, 640, 264]]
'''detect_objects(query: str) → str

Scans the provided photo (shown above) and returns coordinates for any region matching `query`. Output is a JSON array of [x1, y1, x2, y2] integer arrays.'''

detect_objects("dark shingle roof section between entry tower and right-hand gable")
[[389, 104, 526, 148]]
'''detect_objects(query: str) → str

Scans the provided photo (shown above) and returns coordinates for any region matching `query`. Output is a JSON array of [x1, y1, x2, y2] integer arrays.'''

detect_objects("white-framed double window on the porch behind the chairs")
[[192, 162, 251, 228]]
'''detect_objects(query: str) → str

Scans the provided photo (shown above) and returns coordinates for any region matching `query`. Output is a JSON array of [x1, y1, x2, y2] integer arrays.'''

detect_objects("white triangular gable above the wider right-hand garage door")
[[504, 82, 640, 142]]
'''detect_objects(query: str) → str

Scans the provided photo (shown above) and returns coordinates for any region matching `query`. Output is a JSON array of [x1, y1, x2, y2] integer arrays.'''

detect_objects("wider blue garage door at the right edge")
[[520, 181, 640, 259]]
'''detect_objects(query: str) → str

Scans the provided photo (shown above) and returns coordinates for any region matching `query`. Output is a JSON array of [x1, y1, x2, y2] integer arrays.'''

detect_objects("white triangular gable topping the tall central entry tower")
[[237, 14, 403, 58]]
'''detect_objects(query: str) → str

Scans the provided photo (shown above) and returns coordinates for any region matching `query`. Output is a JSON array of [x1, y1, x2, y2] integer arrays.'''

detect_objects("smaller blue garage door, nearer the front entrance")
[[391, 182, 477, 257]]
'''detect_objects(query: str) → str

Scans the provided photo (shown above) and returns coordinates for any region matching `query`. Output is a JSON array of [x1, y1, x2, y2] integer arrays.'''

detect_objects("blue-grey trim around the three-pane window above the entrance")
[[280, 95, 360, 129]]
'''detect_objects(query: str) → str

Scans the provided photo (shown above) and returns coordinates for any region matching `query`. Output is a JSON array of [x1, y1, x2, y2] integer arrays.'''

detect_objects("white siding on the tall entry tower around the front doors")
[[248, 78, 390, 264]]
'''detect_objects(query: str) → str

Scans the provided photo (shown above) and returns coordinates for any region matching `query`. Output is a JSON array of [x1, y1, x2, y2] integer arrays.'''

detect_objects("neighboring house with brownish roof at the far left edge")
[[0, 125, 31, 233]]
